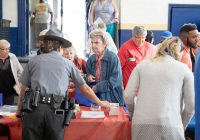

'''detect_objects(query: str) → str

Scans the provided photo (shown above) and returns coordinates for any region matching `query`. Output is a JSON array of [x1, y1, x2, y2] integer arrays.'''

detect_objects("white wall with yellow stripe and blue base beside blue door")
[[119, 0, 200, 45]]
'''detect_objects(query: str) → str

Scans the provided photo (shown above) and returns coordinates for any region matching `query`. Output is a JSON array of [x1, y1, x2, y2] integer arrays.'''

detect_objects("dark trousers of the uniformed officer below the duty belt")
[[22, 104, 65, 140]]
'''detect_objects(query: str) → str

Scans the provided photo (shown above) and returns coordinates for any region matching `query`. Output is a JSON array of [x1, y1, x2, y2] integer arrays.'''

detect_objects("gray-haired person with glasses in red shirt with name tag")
[[117, 26, 156, 88]]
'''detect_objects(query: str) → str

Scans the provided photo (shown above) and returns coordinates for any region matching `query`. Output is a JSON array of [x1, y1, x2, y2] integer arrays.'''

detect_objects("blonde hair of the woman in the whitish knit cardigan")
[[152, 36, 181, 61]]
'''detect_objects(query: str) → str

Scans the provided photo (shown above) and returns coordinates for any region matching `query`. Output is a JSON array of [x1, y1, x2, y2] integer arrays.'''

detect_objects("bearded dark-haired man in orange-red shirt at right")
[[180, 24, 198, 70]]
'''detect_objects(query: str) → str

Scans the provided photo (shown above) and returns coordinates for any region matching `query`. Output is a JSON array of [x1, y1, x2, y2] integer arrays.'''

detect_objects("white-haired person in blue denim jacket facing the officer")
[[86, 29, 124, 106]]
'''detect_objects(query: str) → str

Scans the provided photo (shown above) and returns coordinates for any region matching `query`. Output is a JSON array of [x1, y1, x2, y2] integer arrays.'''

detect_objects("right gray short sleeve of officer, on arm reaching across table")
[[71, 64, 85, 87]]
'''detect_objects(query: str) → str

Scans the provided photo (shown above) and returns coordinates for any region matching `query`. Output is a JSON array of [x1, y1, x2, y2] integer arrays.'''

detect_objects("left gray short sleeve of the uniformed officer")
[[19, 63, 31, 87]]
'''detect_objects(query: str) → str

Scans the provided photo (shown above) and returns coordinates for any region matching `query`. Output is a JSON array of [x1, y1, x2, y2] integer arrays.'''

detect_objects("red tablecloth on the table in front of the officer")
[[0, 106, 131, 140]]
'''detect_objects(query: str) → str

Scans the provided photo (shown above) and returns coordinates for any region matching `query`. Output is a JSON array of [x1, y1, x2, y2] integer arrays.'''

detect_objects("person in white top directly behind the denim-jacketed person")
[[84, 22, 118, 58]]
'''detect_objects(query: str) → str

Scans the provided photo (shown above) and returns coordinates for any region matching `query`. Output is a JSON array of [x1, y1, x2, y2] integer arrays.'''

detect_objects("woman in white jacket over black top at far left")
[[0, 40, 23, 105]]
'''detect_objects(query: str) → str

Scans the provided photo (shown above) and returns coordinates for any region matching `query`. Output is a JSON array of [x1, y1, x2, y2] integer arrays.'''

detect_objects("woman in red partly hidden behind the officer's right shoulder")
[[63, 46, 86, 98]]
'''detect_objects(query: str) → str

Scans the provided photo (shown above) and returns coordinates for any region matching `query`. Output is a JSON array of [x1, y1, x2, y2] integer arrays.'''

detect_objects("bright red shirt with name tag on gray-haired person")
[[117, 39, 157, 88]]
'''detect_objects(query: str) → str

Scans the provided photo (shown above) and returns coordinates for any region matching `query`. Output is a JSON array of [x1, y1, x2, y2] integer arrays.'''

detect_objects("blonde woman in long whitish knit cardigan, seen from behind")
[[124, 37, 194, 140]]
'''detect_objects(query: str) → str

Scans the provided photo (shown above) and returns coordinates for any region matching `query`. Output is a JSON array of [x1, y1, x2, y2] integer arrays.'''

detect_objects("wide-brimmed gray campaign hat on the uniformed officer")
[[37, 28, 72, 48]]
